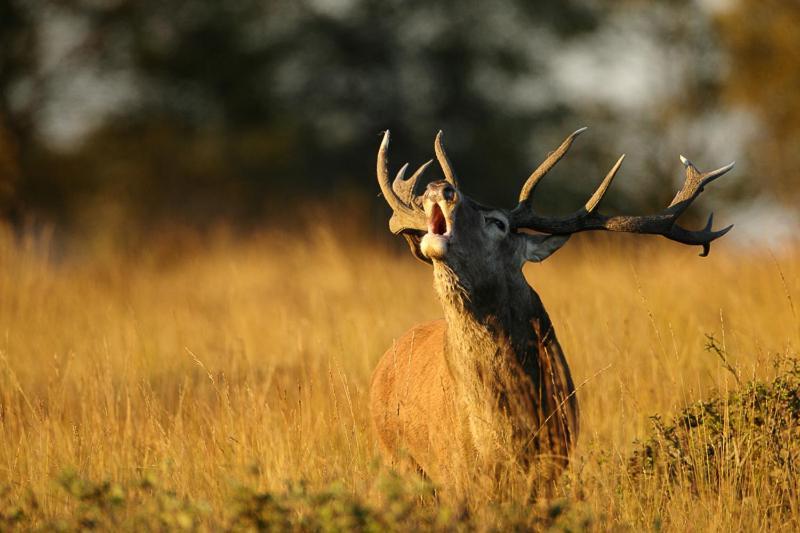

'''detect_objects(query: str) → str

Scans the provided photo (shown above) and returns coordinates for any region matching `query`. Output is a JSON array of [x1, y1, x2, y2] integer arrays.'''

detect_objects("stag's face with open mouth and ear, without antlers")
[[419, 180, 567, 275]]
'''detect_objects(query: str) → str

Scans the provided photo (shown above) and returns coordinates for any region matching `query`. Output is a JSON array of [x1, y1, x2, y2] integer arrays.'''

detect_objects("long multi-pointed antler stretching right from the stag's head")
[[510, 128, 734, 256]]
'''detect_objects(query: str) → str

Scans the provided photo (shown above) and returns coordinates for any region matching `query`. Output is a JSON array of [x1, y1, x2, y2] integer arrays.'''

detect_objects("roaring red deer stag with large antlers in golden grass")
[[370, 128, 733, 487]]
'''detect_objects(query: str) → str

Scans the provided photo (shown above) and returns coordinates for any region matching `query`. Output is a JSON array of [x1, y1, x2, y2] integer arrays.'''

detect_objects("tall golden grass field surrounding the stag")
[[0, 222, 800, 531]]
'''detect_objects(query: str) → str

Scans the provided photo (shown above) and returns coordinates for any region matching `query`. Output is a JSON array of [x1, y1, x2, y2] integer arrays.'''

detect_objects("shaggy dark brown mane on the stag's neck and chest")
[[434, 262, 578, 467]]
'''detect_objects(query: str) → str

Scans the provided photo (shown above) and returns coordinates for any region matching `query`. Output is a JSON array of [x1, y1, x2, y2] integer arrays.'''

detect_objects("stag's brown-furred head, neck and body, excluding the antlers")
[[370, 182, 578, 492]]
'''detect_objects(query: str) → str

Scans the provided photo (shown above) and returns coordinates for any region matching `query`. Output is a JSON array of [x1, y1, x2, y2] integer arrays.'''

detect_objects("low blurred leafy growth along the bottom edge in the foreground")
[[0, 470, 591, 532]]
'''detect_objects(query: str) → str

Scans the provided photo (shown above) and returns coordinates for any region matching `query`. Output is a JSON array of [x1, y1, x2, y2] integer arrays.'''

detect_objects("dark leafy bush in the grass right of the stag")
[[629, 350, 800, 507]]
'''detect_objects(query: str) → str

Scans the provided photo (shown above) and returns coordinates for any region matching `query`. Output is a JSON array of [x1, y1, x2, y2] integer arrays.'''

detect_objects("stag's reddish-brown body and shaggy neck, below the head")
[[370, 278, 578, 484]]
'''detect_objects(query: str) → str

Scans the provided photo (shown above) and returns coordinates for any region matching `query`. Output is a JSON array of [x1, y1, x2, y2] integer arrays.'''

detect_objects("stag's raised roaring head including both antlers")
[[378, 128, 733, 290]]
